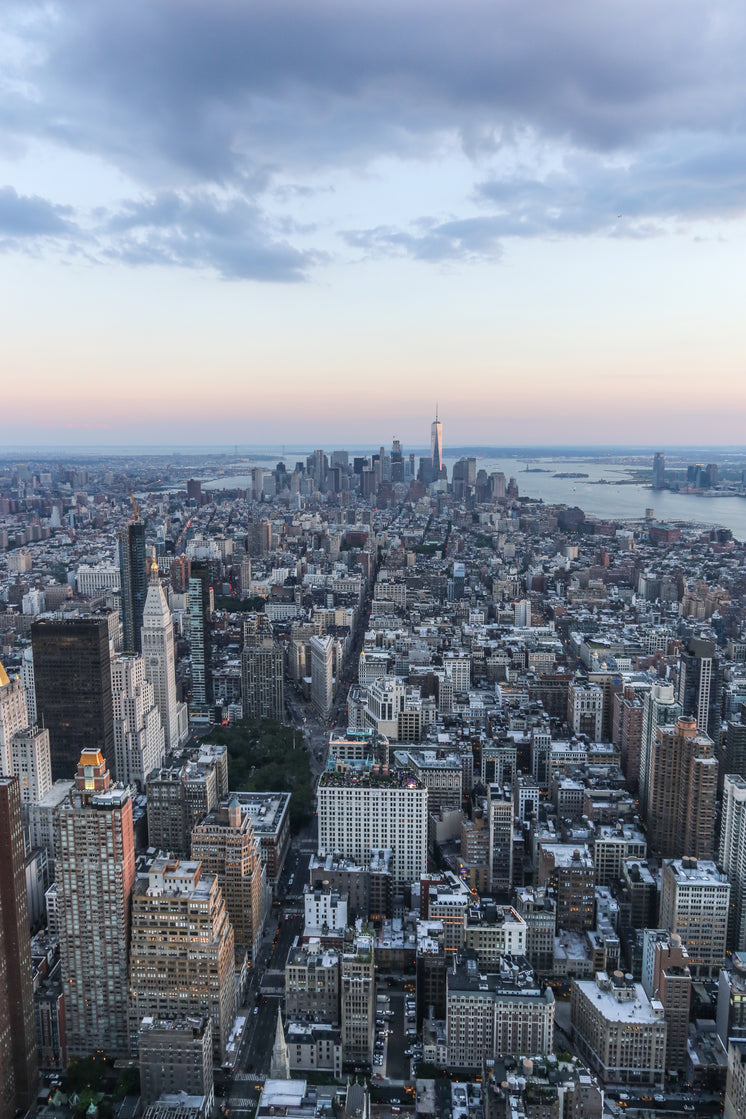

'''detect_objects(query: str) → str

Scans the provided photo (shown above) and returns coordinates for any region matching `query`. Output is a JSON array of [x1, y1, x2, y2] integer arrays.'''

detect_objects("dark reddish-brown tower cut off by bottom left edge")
[[0, 777, 39, 1119]]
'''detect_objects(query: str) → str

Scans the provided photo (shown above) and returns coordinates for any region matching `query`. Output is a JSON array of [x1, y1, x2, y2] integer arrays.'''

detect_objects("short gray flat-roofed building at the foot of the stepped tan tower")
[[138, 1015, 215, 1115]]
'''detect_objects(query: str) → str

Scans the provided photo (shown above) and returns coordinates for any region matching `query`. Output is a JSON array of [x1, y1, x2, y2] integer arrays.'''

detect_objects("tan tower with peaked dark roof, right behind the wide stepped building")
[[191, 797, 264, 960]]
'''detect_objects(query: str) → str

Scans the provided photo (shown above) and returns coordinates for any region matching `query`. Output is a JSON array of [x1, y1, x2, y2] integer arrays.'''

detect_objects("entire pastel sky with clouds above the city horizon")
[[0, 0, 746, 450]]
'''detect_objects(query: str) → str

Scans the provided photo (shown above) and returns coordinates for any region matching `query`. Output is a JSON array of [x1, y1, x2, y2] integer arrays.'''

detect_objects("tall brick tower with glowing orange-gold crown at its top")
[[55, 750, 135, 1056]]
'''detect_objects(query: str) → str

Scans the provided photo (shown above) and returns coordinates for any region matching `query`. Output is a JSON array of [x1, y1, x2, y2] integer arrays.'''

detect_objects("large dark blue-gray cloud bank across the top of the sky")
[[12, 0, 746, 182]]
